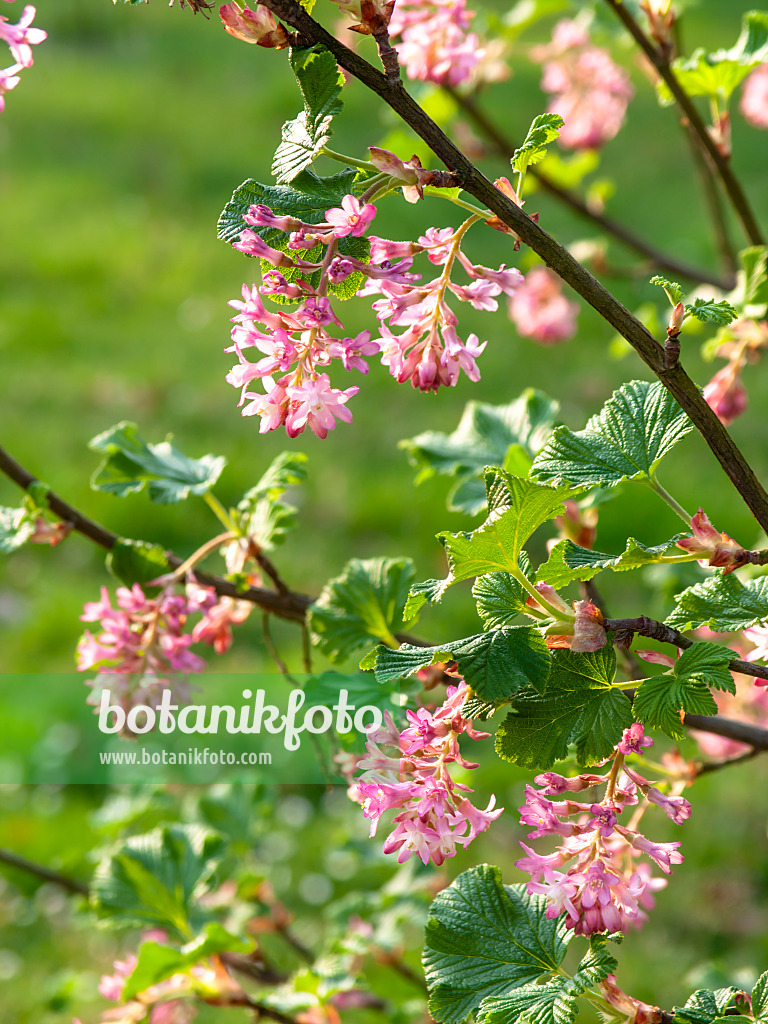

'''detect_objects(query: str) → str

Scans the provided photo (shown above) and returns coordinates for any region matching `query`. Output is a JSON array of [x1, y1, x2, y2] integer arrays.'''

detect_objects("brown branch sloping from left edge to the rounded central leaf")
[[0, 447, 313, 623]]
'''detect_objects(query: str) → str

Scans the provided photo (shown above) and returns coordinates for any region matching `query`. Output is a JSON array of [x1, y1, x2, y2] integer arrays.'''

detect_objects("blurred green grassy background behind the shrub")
[[0, 0, 768, 1024]]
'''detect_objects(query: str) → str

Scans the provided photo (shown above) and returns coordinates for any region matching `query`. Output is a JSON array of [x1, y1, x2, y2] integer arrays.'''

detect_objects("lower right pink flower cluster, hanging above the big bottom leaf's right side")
[[515, 723, 690, 935]]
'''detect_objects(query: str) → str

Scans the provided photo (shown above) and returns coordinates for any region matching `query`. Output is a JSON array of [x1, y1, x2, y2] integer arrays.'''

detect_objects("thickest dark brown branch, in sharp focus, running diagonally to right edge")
[[263, 0, 768, 532]]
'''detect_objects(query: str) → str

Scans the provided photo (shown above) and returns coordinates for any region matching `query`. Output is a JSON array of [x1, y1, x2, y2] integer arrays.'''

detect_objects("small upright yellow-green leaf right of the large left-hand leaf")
[[237, 452, 307, 551]]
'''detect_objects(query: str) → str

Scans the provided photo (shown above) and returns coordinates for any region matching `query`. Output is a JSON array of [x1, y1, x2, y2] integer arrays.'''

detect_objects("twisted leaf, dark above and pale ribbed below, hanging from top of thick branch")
[[272, 45, 344, 184]]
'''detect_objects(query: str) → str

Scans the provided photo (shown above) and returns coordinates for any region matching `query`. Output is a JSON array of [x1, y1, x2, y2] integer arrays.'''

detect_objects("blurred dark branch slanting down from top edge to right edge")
[[605, 0, 765, 246]]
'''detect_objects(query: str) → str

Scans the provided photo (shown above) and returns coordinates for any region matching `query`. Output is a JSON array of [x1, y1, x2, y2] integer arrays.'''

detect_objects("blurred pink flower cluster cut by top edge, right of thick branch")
[[389, 0, 485, 86]]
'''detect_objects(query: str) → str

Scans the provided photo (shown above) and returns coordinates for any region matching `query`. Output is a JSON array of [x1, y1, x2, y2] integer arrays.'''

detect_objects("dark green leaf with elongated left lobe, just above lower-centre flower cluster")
[[374, 626, 550, 702]]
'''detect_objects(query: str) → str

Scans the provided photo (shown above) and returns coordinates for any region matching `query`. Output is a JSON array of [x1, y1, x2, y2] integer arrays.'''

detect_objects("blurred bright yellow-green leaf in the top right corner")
[[657, 10, 768, 104]]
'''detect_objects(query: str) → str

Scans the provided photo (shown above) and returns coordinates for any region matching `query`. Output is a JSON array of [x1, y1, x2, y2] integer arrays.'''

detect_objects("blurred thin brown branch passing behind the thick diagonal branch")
[[443, 86, 735, 292]]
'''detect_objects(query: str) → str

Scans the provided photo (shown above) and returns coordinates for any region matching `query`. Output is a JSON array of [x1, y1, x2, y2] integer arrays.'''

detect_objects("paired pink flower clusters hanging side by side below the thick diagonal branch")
[[226, 196, 522, 437]]
